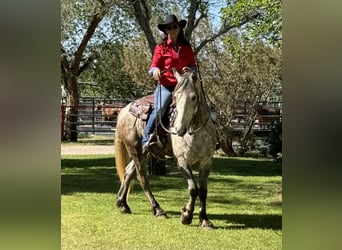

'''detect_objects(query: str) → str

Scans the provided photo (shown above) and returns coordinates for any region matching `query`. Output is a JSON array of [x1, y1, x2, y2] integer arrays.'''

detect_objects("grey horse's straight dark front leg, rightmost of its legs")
[[198, 160, 214, 229]]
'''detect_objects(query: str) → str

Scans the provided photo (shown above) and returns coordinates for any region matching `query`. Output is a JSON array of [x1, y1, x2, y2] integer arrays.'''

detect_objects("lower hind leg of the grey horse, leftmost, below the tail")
[[116, 160, 136, 214]]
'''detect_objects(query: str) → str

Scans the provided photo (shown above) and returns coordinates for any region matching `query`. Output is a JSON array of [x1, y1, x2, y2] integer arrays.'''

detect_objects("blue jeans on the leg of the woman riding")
[[142, 84, 175, 145]]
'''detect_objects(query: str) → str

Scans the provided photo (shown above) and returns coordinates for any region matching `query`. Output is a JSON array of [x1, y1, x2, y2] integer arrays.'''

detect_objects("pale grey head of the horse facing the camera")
[[173, 69, 199, 136]]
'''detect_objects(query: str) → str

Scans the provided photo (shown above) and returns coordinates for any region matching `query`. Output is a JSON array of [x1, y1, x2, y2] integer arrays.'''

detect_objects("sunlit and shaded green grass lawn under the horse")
[[61, 155, 282, 250]]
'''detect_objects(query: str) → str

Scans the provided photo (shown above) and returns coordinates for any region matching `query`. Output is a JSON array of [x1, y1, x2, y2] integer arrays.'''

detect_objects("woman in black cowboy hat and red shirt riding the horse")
[[142, 15, 197, 152]]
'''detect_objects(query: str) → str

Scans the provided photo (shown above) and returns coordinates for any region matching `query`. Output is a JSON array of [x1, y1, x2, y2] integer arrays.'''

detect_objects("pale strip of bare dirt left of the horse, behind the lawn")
[[61, 145, 114, 155]]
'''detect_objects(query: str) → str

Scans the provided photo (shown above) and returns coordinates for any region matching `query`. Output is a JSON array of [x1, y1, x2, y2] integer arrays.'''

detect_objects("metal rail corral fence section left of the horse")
[[61, 97, 132, 138]]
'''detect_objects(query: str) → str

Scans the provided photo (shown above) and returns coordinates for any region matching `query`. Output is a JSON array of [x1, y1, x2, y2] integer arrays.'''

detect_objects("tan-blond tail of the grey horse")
[[114, 131, 130, 183]]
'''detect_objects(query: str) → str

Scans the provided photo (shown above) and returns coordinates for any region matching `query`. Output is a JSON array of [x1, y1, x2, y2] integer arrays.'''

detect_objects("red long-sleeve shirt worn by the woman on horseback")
[[150, 39, 196, 86]]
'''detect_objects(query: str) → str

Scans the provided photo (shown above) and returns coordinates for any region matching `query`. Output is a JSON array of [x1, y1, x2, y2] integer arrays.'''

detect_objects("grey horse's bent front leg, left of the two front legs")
[[178, 160, 198, 225]]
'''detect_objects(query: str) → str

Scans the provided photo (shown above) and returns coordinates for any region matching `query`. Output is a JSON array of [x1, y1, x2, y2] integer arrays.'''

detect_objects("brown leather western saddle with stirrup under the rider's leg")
[[129, 94, 176, 159]]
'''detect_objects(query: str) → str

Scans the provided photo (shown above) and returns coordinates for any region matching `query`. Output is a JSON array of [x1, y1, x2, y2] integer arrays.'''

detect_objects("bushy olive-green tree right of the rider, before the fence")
[[200, 36, 282, 153]]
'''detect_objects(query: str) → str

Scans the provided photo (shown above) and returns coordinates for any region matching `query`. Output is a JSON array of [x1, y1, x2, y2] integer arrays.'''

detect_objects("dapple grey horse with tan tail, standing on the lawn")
[[115, 69, 217, 229]]
